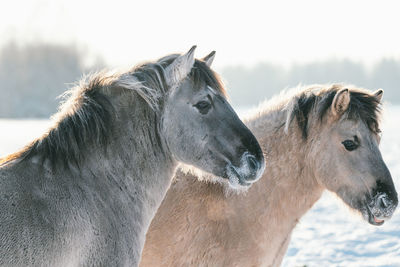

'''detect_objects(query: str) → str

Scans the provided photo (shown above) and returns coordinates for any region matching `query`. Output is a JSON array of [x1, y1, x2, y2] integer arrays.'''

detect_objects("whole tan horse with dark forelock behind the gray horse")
[[141, 85, 398, 267]]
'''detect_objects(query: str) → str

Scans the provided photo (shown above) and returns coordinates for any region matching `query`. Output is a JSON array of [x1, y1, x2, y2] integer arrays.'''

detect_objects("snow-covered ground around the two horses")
[[0, 106, 400, 267]]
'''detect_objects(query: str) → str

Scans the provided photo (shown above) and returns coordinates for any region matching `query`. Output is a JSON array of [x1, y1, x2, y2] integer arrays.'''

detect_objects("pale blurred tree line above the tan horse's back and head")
[[221, 59, 400, 107]]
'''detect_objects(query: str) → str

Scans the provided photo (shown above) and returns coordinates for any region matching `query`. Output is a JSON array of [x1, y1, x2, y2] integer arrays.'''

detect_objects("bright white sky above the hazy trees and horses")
[[0, 0, 400, 67]]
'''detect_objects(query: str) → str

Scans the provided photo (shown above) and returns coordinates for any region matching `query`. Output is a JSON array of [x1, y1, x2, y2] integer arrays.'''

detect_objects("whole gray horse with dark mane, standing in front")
[[0, 47, 265, 266]]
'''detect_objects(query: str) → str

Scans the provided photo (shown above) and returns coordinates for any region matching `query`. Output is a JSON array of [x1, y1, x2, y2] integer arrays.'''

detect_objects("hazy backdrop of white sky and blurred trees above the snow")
[[0, 0, 400, 118]]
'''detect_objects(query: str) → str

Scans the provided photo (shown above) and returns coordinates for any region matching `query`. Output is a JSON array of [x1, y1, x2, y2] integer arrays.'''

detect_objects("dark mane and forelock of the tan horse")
[[285, 84, 381, 140]]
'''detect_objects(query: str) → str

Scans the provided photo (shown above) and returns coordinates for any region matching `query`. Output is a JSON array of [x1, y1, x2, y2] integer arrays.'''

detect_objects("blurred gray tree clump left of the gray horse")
[[0, 42, 103, 118]]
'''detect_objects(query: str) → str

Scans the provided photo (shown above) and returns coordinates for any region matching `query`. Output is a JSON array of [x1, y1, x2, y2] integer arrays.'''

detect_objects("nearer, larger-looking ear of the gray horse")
[[165, 45, 196, 87]]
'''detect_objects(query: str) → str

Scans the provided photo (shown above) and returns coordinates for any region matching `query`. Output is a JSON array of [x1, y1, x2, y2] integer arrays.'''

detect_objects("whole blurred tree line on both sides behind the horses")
[[0, 43, 400, 118]]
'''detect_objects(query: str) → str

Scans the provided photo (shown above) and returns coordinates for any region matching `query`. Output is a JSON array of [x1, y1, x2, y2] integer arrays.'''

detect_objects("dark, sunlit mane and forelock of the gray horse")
[[0, 54, 226, 168]]
